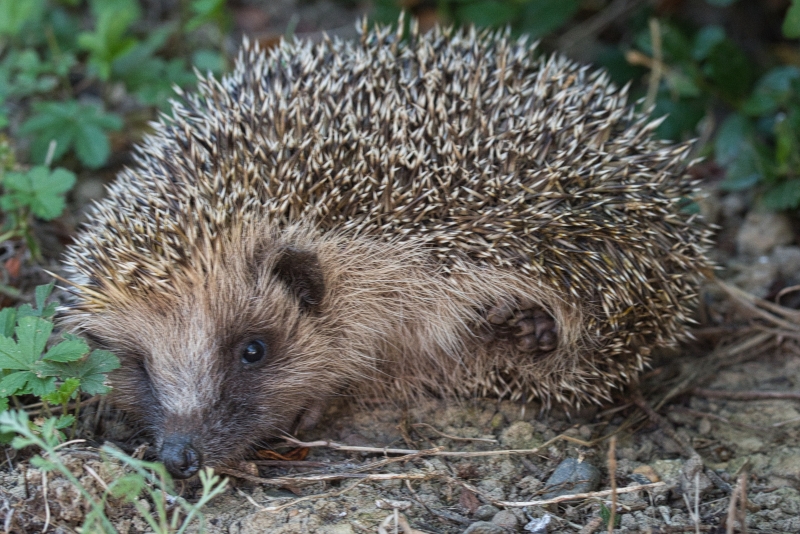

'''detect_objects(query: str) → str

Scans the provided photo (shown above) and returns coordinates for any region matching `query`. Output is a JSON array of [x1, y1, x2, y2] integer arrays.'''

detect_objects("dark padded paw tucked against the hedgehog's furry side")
[[486, 302, 558, 353]]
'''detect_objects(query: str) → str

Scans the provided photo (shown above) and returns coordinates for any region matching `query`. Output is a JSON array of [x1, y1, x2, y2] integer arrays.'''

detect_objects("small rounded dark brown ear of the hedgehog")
[[272, 246, 325, 311]]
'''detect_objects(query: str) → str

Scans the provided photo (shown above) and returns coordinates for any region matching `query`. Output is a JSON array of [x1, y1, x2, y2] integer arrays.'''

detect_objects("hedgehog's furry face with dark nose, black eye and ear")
[[76, 243, 332, 478]]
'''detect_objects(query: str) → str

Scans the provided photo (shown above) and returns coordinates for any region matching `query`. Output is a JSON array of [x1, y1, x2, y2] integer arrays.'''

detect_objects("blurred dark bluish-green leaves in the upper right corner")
[[628, 6, 800, 210]]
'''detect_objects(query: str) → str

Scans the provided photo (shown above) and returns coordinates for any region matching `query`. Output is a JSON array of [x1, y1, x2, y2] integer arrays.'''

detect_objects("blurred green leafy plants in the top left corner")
[[0, 0, 230, 174]]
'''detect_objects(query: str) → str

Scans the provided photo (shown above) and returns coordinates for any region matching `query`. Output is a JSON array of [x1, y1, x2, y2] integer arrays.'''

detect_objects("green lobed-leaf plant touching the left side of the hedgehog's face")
[[0, 283, 119, 438]]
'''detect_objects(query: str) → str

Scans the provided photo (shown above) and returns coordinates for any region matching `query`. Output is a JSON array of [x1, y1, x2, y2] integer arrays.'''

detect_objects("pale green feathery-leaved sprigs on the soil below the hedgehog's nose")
[[0, 411, 228, 534]]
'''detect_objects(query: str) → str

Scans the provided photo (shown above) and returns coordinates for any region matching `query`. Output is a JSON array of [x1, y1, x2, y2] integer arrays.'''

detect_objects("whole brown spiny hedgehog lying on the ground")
[[63, 22, 712, 478]]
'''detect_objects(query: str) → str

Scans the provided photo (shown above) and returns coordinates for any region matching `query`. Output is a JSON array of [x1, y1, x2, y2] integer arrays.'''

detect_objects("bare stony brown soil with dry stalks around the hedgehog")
[[0, 1, 800, 534]]
